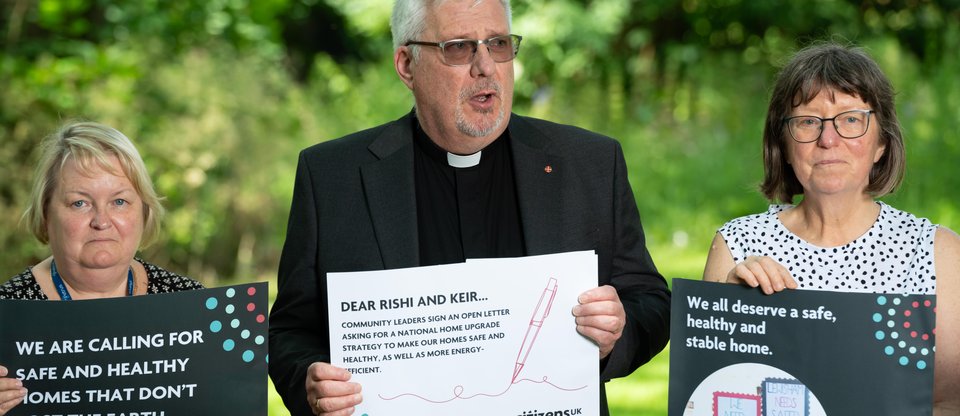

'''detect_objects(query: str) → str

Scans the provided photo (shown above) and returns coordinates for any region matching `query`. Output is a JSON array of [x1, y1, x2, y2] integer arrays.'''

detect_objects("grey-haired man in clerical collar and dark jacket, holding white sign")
[[270, 0, 670, 415]]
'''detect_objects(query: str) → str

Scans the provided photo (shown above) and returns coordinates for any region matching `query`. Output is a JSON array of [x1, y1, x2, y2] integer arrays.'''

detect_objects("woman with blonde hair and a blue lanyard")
[[0, 122, 203, 416]]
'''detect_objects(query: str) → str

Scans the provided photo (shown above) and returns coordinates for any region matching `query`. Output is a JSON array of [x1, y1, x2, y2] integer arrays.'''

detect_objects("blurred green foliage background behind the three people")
[[0, 0, 960, 415]]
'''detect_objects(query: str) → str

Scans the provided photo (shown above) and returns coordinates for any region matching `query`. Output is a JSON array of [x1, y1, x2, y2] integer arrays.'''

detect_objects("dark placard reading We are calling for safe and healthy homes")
[[0, 282, 268, 416]]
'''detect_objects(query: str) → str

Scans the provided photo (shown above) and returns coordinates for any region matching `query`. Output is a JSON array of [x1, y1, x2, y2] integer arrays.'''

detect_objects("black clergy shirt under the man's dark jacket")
[[414, 120, 525, 266]]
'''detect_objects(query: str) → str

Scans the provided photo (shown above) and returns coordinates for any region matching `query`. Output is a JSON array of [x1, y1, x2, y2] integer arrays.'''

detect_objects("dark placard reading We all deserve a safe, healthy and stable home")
[[668, 279, 936, 416]]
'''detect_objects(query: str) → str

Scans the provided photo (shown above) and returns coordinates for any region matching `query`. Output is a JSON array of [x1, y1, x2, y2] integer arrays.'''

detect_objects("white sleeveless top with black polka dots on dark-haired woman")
[[719, 202, 937, 294]]
